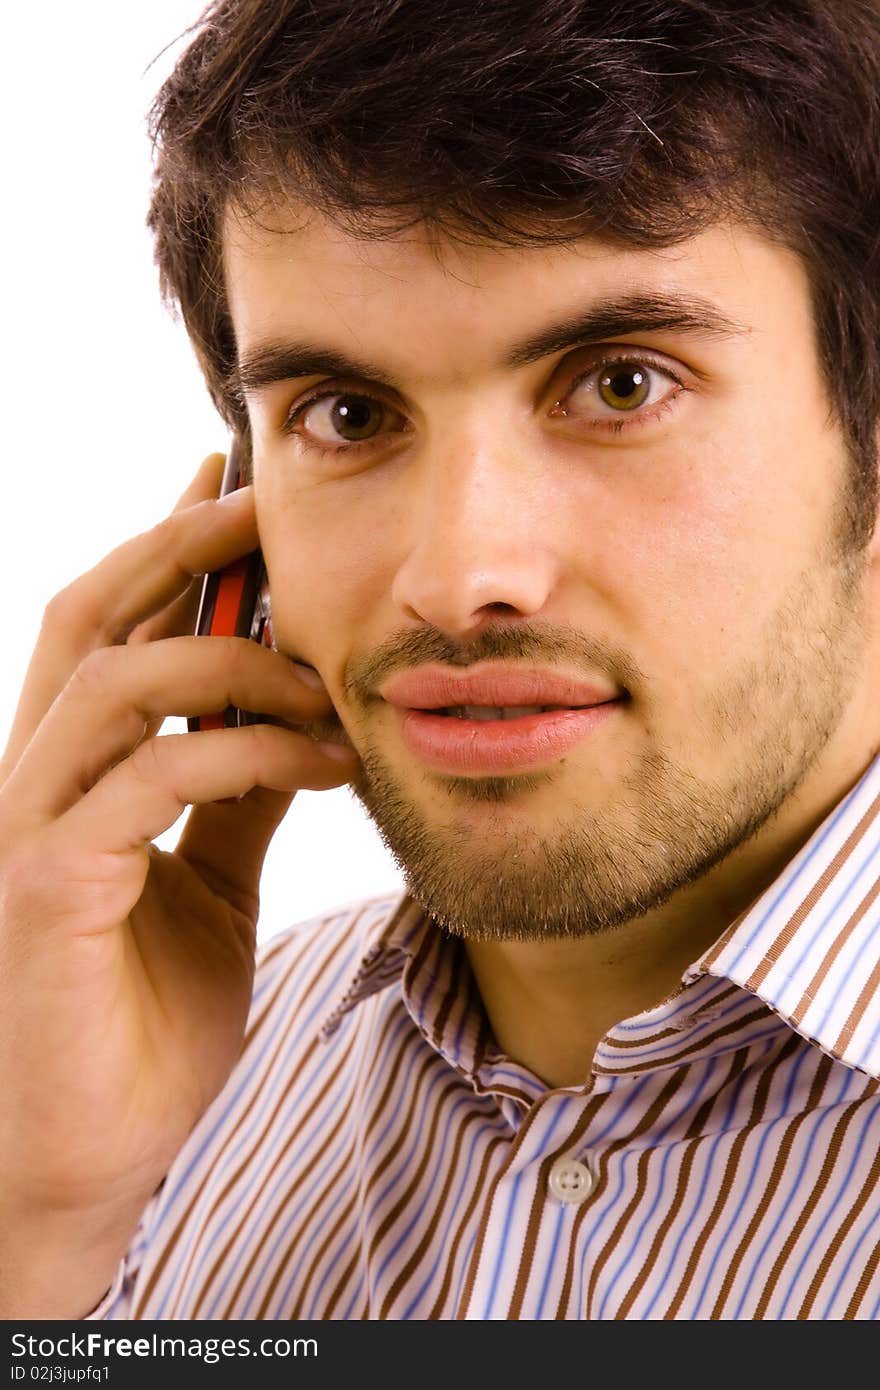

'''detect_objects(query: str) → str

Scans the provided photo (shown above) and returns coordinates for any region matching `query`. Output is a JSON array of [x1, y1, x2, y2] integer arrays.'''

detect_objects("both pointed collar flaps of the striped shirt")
[[321, 756, 880, 1077]]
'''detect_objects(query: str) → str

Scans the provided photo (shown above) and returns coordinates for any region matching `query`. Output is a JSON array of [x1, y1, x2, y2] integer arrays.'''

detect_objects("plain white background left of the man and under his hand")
[[0, 0, 402, 937]]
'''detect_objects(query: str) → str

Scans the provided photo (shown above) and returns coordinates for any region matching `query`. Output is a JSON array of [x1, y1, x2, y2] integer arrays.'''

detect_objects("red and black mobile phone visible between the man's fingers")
[[186, 435, 272, 734]]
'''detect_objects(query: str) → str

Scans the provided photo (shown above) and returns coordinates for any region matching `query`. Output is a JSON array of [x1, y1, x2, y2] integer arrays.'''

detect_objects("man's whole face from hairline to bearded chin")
[[225, 209, 877, 938]]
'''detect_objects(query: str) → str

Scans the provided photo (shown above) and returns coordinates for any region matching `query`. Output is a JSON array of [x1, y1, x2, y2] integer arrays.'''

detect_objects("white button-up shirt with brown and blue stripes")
[[90, 758, 880, 1319]]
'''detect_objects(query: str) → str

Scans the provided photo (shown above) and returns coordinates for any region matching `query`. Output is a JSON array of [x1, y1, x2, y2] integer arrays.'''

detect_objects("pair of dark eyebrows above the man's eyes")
[[234, 293, 751, 396]]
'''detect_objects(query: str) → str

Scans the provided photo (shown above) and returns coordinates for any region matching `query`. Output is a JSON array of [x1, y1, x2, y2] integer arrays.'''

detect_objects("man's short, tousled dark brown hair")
[[147, 0, 880, 545]]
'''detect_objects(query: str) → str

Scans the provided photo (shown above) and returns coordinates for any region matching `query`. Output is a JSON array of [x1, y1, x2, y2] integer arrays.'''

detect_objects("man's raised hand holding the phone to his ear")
[[0, 455, 356, 1316]]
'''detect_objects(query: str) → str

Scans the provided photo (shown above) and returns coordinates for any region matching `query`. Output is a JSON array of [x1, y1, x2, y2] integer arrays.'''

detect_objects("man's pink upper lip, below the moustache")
[[380, 662, 620, 723]]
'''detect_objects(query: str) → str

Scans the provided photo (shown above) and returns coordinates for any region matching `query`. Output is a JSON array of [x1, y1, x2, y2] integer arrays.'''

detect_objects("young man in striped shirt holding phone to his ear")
[[0, 0, 880, 1319]]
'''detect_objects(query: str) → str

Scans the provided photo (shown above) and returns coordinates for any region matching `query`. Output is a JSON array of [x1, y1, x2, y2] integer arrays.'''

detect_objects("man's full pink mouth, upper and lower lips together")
[[380, 663, 623, 776]]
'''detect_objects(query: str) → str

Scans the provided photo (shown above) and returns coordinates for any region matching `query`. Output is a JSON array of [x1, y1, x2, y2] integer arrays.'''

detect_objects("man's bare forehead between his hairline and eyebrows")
[[224, 200, 812, 379]]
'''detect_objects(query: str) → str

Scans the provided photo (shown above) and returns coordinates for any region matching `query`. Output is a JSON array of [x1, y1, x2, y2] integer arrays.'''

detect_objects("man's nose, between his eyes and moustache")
[[392, 435, 557, 635]]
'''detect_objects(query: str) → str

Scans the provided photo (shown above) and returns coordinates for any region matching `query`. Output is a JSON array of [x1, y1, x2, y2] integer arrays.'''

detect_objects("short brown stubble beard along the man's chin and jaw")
[[339, 530, 865, 941]]
